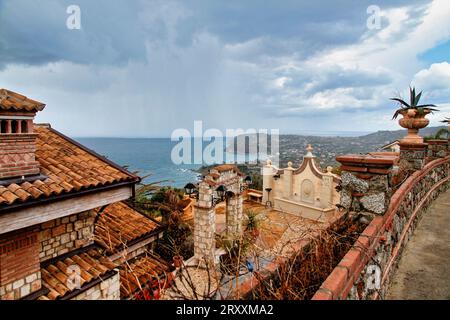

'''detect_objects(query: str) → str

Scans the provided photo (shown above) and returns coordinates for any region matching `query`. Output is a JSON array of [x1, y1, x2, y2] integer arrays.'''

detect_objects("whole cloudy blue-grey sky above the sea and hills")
[[0, 0, 450, 137]]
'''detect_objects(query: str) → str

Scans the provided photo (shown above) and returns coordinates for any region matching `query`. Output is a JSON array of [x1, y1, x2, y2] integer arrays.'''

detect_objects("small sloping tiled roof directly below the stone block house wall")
[[39, 249, 117, 300]]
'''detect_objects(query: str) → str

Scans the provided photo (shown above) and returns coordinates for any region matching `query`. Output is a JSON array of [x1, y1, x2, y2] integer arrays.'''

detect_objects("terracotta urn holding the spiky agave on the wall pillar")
[[398, 109, 431, 144]]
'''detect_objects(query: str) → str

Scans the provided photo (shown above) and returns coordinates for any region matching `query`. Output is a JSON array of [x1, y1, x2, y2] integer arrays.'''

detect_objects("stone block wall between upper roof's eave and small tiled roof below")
[[39, 211, 95, 262]]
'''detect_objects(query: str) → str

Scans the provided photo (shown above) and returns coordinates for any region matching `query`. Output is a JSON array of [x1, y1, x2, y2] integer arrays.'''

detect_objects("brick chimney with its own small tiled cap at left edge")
[[0, 89, 45, 182]]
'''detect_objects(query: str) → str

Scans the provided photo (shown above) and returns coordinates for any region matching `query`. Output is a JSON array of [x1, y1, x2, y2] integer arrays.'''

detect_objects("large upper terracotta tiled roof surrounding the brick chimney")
[[0, 126, 139, 209]]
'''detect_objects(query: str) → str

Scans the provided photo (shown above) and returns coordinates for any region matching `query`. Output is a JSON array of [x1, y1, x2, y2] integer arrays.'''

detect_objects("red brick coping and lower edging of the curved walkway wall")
[[312, 156, 450, 300]]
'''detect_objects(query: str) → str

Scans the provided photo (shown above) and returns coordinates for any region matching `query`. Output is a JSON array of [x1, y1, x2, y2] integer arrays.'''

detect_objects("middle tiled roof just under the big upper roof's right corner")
[[95, 202, 161, 253]]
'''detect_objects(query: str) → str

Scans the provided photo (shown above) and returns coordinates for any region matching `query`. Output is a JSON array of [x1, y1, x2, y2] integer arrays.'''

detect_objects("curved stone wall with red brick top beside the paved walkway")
[[313, 156, 450, 300]]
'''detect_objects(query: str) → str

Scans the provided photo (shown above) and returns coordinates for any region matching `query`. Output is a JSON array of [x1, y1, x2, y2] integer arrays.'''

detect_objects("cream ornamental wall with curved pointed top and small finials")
[[262, 145, 340, 221]]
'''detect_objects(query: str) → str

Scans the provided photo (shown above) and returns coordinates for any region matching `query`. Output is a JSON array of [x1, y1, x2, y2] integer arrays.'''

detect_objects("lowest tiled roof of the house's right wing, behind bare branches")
[[120, 256, 170, 299]]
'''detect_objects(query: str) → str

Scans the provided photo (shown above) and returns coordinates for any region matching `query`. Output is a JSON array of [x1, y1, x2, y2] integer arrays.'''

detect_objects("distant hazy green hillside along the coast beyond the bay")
[[227, 126, 447, 167]]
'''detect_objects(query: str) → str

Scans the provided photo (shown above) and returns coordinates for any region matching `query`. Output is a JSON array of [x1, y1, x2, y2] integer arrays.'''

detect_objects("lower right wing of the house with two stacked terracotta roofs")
[[95, 202, 173, 299]]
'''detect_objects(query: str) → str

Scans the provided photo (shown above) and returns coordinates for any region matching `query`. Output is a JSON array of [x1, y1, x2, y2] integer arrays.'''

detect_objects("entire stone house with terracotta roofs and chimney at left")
[[0, 89, 167, 300]]
